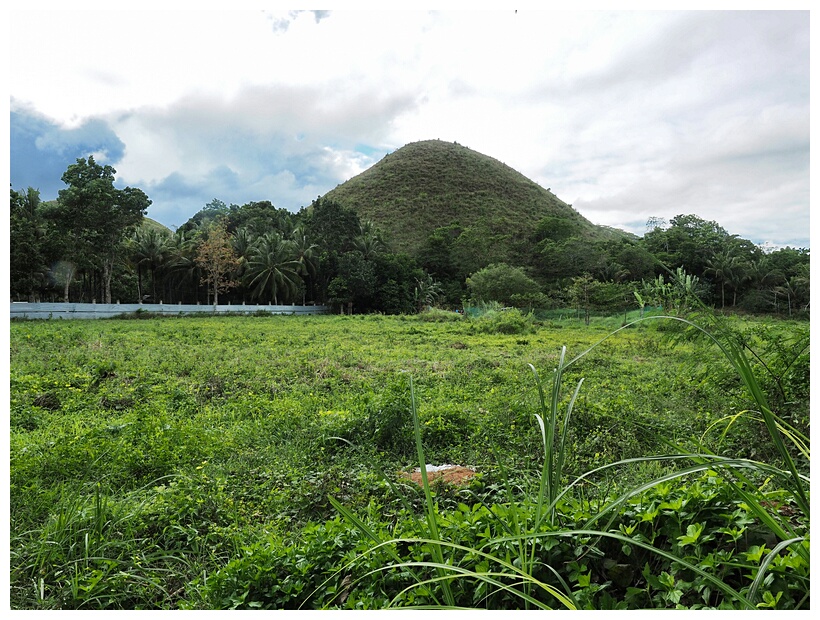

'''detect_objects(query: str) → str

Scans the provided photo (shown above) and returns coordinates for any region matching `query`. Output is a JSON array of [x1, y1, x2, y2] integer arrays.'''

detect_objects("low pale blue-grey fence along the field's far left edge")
[[10, 301, 329, 319]]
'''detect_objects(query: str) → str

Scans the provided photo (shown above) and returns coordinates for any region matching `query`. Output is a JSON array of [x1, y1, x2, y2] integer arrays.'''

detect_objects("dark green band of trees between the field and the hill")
[[10, 157, 809, 317]]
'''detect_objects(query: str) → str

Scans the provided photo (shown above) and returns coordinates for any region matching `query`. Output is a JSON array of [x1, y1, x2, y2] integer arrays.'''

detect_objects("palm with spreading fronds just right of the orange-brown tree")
[[245, 232, 301, 305]]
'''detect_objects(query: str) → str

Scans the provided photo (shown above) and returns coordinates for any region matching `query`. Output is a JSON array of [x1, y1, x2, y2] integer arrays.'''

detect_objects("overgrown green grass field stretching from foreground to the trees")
[[9, 312, 809, 609]]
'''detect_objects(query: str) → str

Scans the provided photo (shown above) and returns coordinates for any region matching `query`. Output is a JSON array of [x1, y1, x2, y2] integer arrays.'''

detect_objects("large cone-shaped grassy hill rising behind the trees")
[[324, 140, 626, 254]]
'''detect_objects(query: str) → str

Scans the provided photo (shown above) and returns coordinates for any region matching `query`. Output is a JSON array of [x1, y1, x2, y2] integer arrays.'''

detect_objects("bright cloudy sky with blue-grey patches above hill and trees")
[[8, 0, 810, 247]]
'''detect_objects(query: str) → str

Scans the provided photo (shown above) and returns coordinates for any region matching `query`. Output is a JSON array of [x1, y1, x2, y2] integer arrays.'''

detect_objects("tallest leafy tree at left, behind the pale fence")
[[53, 157, 151, 303]]
